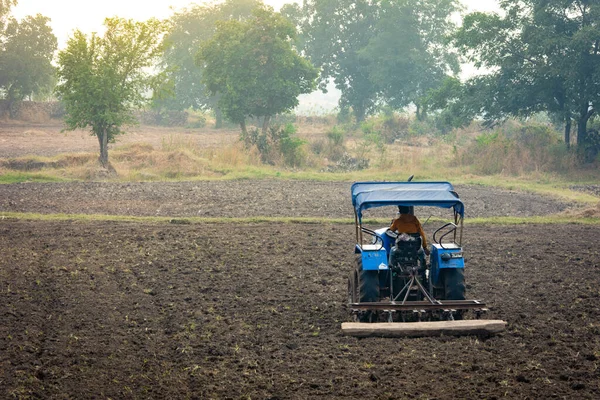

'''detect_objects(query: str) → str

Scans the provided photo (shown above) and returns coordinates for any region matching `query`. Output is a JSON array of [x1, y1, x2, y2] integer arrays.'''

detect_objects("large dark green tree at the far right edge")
[[455, 0, 600, 148]]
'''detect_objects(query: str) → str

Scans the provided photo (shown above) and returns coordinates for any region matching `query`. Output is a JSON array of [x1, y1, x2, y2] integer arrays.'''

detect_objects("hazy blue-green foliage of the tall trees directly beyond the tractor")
[[302, 0, 458, 122]]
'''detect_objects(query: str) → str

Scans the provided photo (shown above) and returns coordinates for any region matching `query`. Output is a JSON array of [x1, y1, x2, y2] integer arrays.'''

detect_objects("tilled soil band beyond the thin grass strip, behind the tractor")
[[0, 180, 572, 219]]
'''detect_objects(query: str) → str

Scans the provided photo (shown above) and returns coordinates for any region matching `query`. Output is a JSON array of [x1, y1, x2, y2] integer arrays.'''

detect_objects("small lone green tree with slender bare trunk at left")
[[57, 18, 164, 168]]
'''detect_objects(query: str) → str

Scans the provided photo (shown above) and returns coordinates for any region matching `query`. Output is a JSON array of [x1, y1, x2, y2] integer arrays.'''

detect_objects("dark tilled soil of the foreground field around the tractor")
[[0, 220, 600, 399]]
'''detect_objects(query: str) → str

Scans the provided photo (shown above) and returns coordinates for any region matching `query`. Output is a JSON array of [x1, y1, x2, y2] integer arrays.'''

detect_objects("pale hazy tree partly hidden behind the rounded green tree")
[[155, 0, 261, 127]]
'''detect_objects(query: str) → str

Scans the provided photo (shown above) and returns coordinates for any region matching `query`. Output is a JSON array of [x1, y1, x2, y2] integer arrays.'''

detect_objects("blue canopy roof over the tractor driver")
[[352, 182, 465, 220]]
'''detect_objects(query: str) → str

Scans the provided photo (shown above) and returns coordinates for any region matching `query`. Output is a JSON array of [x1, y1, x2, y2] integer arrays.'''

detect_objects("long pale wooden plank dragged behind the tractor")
[[342, 319, 506, 337]]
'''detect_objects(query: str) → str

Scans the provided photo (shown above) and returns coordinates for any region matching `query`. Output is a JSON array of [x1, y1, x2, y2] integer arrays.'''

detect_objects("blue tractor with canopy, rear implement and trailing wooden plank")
[[342, 181, 506, 337]]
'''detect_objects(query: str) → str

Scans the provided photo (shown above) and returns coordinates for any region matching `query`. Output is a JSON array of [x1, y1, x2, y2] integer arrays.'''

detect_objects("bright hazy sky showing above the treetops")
[[13, 0, 497, 48]]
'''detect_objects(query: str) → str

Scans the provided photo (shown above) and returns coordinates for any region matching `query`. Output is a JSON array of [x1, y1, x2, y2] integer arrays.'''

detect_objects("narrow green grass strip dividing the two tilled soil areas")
[[0, 212, 600, 226]]
